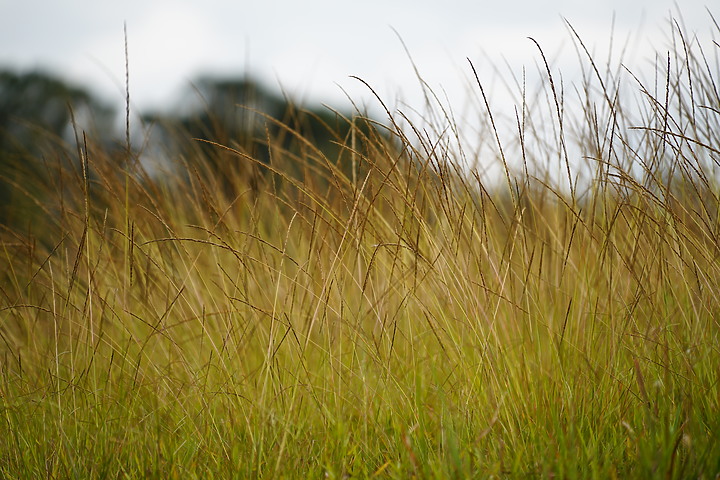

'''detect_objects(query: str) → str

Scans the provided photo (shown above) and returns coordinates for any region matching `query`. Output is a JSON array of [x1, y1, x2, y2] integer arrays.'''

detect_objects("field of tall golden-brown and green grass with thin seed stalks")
[[0, 16, 720, 479]]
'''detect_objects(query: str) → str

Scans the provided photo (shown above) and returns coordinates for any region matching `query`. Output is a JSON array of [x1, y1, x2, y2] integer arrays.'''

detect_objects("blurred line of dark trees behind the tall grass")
[[0, 70, 371, 231]]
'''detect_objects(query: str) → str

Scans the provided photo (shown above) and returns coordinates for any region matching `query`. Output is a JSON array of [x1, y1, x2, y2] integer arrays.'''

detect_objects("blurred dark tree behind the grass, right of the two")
[[143, 77, 370, 199]]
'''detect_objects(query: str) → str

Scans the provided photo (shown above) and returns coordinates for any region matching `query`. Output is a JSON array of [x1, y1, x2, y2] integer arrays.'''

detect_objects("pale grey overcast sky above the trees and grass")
[[0, 0, 720, 117]]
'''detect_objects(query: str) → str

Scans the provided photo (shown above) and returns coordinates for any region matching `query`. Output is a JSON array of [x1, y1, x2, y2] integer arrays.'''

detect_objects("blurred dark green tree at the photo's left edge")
[[0, 70, 114, 226]]
